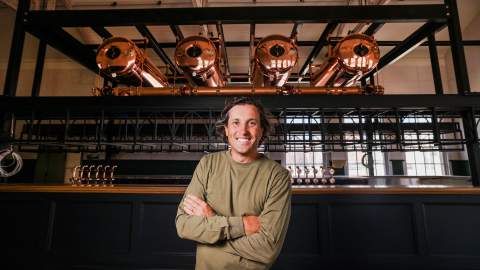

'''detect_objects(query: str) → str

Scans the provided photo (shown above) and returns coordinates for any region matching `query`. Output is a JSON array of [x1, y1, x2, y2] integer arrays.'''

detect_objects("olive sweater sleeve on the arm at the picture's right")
[[223, 171, 291, 264]]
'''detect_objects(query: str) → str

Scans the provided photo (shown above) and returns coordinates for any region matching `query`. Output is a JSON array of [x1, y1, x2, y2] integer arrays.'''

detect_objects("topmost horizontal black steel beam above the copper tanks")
[[24, 5, 447, 27]]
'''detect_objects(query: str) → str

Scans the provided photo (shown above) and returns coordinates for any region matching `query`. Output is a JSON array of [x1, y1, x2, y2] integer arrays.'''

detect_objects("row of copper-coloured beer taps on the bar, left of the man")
[[70, 165, 118, 187]]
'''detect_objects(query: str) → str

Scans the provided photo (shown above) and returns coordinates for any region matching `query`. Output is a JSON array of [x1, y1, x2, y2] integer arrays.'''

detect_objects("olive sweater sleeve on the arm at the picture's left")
[[175, 158, 245, 244]]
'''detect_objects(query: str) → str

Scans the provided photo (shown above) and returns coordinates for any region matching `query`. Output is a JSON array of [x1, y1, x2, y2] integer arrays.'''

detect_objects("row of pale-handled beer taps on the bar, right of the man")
[[287, 166, 335, 185]]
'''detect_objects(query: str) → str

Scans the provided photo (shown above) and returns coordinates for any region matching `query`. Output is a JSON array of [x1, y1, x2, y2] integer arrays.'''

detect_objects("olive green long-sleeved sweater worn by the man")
[[176, 151, 291, 269]]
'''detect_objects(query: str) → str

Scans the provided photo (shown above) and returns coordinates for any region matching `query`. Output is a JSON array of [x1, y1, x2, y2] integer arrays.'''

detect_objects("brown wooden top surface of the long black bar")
[[0, 184, 480, 195]]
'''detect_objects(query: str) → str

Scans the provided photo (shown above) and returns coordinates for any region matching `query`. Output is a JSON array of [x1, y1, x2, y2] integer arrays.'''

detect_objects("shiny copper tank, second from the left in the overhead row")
[[175, 36, 225, 87]]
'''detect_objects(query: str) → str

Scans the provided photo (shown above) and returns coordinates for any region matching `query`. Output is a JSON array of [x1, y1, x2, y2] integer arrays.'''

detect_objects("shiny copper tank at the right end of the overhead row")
[[311, 34, 380, 87]]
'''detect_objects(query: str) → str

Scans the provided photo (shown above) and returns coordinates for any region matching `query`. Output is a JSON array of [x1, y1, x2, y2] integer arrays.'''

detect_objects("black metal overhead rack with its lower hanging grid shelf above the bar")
[[0, 0, 480, 185]]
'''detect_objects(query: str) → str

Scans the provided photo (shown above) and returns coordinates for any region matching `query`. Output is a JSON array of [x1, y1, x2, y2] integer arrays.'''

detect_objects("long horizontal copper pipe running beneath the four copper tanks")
[[99, 85, 383, 96]]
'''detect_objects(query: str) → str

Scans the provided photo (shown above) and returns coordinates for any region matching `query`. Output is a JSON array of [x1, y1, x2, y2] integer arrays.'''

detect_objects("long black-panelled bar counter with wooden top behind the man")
[[0, 184, 480, 270]]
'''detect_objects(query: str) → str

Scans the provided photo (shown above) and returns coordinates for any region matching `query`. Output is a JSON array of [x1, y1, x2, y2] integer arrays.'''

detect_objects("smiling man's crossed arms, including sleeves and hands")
[[176, 158, 291, 264]]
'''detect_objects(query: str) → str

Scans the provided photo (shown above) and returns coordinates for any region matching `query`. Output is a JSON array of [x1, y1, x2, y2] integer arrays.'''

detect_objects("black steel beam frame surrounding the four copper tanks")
[[0, 0, 480, 186]]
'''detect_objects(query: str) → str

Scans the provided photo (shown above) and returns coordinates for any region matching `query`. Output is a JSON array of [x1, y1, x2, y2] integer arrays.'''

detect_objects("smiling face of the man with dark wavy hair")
[[225, 104, 263, 157]]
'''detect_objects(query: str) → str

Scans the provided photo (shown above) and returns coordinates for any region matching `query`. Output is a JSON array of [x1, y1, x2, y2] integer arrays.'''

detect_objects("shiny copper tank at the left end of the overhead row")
[[96, 37, 168, 87]]
